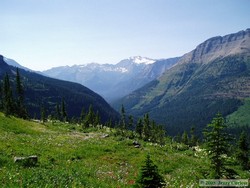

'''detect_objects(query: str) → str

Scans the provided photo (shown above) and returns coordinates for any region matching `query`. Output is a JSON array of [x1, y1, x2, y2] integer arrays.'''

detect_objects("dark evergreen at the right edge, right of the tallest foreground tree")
[[236, 132, 249, 170]]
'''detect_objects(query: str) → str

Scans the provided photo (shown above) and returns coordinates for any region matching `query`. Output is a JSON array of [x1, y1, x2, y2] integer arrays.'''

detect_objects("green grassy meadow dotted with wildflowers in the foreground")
[[0, 113, 250, 187]]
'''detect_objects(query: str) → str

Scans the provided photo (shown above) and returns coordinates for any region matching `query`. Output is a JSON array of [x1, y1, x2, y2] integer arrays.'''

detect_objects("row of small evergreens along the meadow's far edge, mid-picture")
[[41, 101, 166, 145]]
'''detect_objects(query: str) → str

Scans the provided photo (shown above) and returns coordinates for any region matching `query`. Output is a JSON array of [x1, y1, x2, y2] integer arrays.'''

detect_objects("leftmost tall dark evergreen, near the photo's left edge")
[[3, 74, 14, 116]]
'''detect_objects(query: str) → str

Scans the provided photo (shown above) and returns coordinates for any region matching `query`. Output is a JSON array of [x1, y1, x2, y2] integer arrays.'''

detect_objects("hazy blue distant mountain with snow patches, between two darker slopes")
[[43, 56, 179, 102]]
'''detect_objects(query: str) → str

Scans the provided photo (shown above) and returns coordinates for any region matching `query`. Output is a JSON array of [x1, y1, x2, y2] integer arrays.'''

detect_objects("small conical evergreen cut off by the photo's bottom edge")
[[135, 154, 165, 188]]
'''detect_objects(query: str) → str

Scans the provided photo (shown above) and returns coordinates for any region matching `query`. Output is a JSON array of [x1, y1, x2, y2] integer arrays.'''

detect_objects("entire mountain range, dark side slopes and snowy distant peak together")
[[0, 29, 250, 135]]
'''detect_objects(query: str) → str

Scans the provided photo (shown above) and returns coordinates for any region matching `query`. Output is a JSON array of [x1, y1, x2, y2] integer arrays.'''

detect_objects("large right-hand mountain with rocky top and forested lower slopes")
[[114, 29, 250, 133]]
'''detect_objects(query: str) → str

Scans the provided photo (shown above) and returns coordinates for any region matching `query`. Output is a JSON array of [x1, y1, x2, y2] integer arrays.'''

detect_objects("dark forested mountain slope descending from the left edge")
[[0, 55, 119, 122]]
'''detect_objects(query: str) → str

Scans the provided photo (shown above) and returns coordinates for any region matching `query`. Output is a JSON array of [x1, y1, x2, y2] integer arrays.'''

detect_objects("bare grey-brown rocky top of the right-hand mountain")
[[180, 29, 250, 63]]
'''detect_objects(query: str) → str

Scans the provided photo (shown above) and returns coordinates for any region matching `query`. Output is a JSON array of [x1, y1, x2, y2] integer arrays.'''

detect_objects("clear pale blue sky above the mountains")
[[0, 0, 250, 70]]
